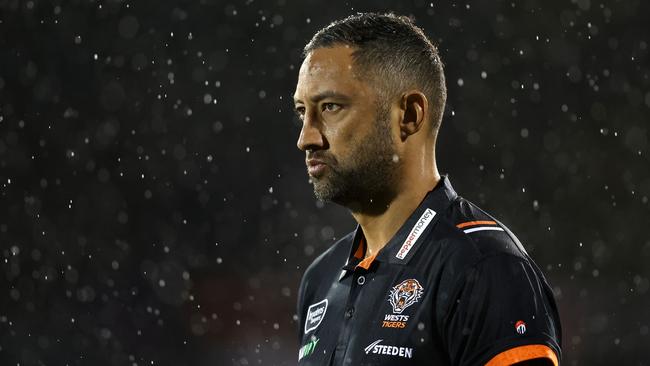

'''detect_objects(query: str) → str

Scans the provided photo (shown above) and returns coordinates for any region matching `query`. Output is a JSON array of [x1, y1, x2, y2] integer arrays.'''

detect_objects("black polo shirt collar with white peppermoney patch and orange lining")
[[340, 175, 458, 279]]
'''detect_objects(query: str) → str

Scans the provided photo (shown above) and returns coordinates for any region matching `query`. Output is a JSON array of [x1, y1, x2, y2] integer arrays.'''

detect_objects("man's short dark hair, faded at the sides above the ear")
[[302, 13, 447, 133]]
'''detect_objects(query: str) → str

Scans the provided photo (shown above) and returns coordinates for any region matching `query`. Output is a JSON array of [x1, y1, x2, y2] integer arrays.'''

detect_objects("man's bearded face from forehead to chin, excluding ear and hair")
[[294, 46, 399, 208]]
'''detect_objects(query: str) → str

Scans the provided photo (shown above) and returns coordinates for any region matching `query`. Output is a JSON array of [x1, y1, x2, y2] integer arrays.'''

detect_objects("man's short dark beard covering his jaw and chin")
[[311, 103, 399, 212]]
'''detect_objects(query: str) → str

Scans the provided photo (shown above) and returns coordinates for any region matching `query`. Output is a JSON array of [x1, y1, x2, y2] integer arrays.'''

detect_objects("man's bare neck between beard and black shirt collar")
[[351, 167, 440, 257]]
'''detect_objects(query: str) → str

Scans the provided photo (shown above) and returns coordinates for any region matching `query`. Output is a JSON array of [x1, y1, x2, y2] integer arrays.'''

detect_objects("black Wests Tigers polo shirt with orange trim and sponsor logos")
[[298, 177, 561, 366]]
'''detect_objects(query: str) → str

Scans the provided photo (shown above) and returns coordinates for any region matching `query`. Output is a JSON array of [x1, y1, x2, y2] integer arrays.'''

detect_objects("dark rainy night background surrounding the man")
[[0, 0, 650, 366]]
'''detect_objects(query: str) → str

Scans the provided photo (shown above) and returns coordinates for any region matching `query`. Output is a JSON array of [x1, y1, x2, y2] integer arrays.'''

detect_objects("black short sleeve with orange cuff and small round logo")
[[442, 254, 561, 366]]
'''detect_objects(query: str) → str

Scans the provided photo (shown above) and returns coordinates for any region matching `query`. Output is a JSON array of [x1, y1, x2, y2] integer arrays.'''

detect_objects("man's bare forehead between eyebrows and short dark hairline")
[[294, 45, 369, 101]]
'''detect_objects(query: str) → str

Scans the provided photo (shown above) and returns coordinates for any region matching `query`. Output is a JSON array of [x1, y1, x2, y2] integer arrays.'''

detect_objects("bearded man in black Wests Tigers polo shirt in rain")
[[294, 13, 561, 366]]
